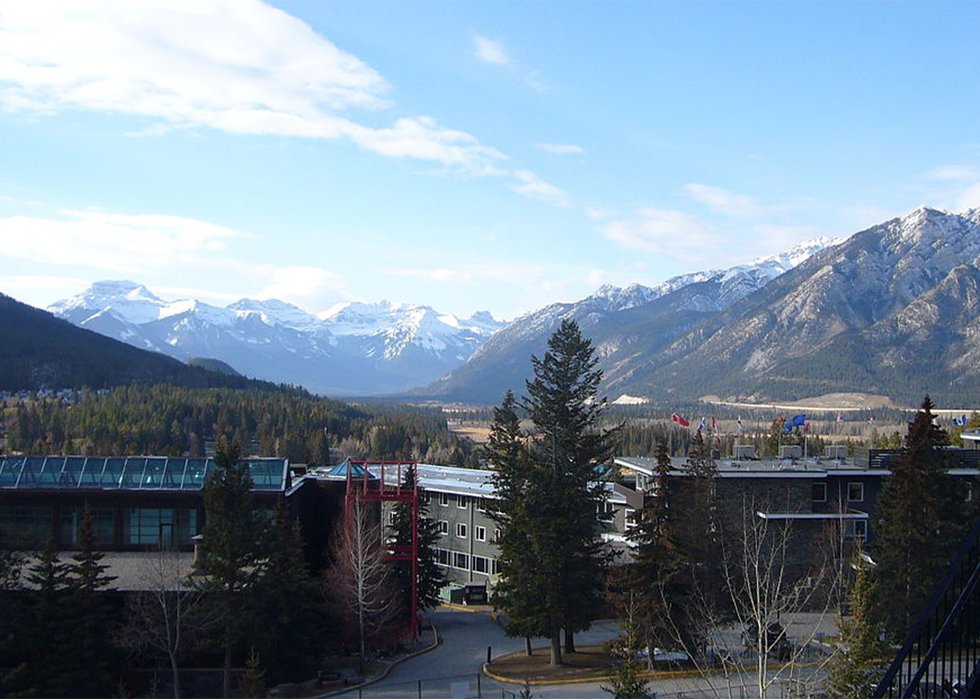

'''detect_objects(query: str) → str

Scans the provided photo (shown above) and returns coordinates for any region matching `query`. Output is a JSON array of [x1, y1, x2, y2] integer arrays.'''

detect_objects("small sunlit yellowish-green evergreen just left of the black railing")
[[827, 548, 888, 699]]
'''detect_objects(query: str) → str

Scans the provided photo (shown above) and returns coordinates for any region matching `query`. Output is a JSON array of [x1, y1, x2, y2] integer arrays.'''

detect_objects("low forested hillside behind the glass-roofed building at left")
[[4, 384, 475, 466]]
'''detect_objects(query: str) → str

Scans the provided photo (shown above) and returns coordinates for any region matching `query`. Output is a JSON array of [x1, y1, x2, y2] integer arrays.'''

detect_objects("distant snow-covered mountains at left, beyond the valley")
[[49, 281, 503, 395]]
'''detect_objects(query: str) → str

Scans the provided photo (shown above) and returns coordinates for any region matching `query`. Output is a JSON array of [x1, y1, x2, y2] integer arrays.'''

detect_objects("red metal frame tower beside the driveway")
[[344, 459, 419, 640]]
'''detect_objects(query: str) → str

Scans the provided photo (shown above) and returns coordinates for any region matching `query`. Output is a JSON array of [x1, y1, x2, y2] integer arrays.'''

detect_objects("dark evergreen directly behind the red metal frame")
[[391, 464, 446, 610]]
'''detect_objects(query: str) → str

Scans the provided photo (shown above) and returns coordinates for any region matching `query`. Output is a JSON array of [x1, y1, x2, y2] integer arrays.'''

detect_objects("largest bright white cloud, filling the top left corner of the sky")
[[0, 0, 503, 174]]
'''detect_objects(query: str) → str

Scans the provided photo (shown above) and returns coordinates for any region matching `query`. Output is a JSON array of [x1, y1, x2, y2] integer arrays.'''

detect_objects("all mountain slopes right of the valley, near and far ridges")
[[422, 208, 980, 405]]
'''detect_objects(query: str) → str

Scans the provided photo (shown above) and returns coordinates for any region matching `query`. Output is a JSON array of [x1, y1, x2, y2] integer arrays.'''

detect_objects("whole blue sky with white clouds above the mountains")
[[0, 0, 980, 319]]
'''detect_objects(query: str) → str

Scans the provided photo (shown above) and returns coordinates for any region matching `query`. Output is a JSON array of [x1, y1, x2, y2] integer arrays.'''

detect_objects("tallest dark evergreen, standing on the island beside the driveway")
[[501, 320, 611, 665]]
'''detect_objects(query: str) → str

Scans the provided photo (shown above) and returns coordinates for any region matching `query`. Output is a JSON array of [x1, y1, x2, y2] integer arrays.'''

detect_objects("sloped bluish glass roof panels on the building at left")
[[0, 456, 288, 490]]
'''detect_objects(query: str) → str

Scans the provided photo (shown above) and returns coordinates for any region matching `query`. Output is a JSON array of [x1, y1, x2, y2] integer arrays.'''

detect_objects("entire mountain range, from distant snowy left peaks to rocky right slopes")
[[36, 208, 980, 405]]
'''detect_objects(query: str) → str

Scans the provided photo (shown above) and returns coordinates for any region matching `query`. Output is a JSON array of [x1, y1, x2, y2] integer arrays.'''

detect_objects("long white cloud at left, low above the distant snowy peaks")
[[0, 210, 247, 274]]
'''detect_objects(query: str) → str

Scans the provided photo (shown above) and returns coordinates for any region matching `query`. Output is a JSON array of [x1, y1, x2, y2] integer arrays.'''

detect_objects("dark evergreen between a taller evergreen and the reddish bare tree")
[[249, 501, 326, 684]]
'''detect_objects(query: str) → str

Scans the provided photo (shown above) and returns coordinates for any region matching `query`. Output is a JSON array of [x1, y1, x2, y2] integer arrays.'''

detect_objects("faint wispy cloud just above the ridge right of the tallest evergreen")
[[601, 207, 723, 262]]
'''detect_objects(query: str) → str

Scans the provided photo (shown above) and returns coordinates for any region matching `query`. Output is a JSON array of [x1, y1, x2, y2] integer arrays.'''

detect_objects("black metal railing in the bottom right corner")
[[873, 519, 980, 699]]
